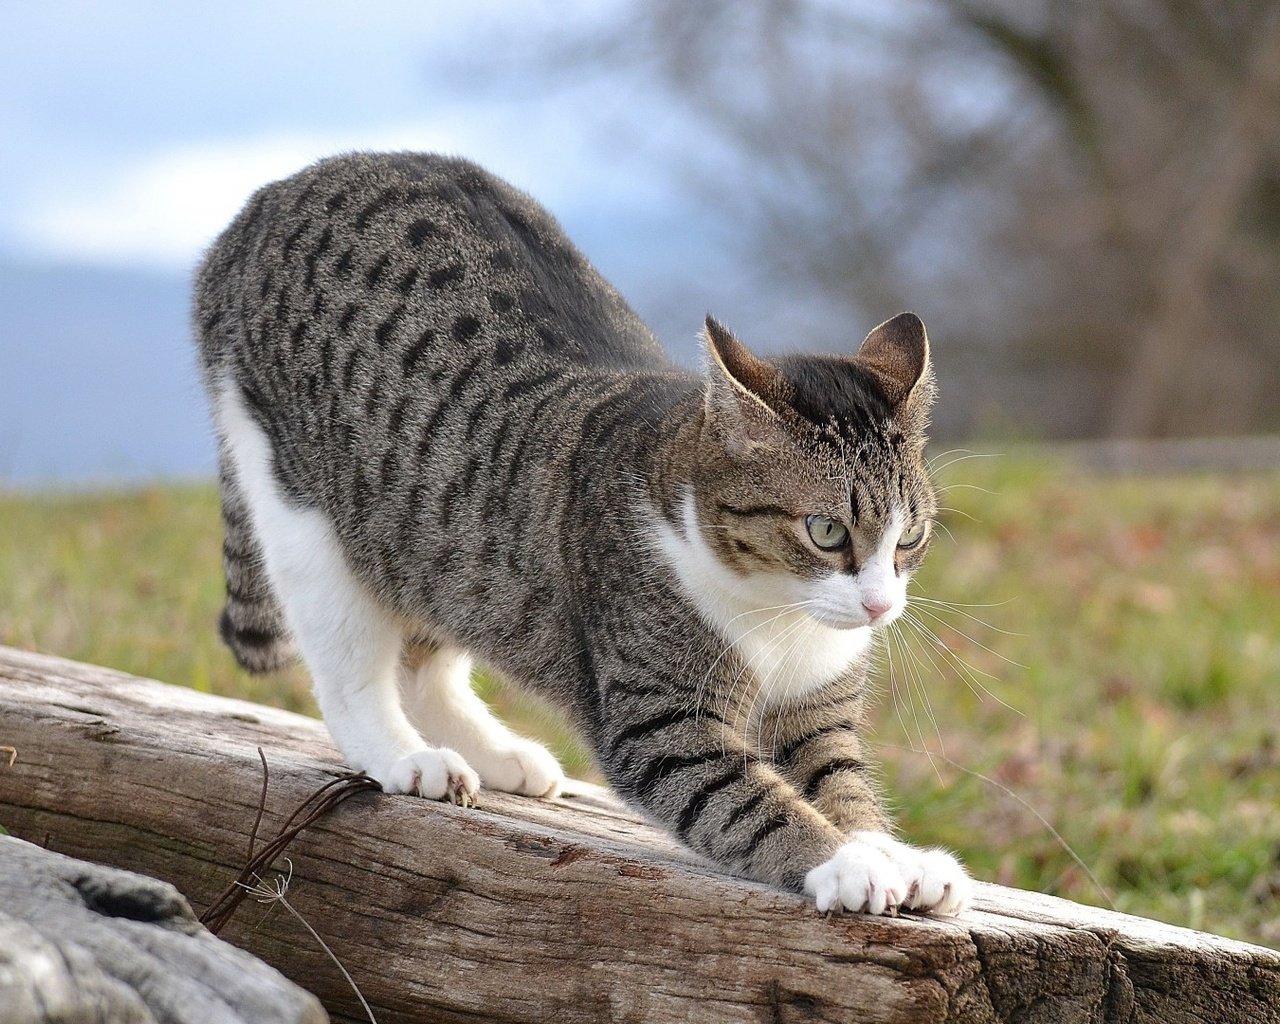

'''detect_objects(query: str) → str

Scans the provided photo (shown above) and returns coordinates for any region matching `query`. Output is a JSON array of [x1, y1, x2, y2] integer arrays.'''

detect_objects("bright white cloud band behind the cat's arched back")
[[5, 108, 653, 270]]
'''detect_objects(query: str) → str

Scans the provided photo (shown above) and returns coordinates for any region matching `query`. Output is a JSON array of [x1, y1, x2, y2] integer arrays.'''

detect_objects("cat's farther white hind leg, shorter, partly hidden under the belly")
[[402, 646, 564, 797]]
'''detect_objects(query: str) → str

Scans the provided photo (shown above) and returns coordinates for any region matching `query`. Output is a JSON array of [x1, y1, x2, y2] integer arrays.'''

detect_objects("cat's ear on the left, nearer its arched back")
[[703, 316, 786, 457]]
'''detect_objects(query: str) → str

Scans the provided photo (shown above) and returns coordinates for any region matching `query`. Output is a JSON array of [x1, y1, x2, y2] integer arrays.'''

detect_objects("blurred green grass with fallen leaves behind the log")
[[0, 456, 1280, 946]]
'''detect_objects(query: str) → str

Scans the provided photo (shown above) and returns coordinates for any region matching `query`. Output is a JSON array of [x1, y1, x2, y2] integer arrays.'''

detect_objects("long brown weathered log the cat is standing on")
[[0, 648, 1280, 1024]]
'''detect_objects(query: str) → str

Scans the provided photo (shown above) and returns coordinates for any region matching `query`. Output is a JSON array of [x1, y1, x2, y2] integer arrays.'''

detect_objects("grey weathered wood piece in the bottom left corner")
[[0, 836, 328, 1024]]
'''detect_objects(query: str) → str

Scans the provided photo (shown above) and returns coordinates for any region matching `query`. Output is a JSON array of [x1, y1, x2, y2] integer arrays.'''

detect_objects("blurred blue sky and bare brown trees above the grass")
[[0, 0, 1280, 485]]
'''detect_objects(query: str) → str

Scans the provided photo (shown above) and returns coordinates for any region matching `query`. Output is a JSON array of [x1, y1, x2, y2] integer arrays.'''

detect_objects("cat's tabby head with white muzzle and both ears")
[[692, 312, 937, 628]]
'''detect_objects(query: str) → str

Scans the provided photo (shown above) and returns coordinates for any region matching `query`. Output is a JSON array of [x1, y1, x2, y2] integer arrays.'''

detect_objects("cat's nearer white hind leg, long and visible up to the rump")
[[218, 387, 480, 803]]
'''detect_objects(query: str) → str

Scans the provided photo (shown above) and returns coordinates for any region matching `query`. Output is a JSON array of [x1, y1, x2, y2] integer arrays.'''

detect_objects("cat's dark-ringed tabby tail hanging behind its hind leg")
[[218, 452, 298, 673]]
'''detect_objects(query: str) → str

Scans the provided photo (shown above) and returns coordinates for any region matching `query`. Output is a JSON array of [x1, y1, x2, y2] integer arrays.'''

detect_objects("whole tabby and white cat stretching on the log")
[[195, 152, 972, 914]]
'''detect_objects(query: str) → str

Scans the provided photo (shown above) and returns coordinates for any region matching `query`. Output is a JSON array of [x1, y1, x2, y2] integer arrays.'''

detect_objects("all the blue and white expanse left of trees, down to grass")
[[0, 0, 748, 488]]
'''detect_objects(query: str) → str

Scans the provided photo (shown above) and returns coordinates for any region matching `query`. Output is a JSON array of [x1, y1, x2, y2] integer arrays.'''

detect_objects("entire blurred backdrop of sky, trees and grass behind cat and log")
[[0, 0, 1280, 945]]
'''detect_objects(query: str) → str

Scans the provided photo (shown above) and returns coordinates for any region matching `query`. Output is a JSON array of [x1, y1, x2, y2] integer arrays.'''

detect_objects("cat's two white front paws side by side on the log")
[[804, 832, 973, 916]]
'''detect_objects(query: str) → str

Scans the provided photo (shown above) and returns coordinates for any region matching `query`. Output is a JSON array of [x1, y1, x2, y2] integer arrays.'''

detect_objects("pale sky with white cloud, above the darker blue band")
[[0, 0, 696, 270]]
